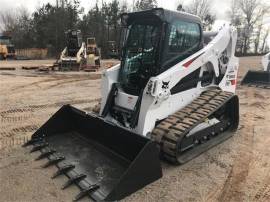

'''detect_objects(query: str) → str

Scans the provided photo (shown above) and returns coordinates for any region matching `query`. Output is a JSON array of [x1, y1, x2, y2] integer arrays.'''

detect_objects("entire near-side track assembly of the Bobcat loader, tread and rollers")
[[151, 89, 239, 164]]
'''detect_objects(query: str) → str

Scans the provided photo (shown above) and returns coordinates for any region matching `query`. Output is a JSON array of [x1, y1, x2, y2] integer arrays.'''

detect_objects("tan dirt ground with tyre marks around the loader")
[[0, 57, 270, 202]]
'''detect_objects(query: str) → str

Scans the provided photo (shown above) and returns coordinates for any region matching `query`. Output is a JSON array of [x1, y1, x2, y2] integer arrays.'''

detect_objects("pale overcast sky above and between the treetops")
[[0, 0, 270, 45]]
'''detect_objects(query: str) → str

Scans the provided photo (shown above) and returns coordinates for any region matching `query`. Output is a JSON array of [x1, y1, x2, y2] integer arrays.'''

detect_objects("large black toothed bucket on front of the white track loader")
[[27, 105, 162, 201]]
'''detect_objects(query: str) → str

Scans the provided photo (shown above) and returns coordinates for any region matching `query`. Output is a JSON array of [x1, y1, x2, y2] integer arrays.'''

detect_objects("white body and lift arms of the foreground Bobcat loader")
[[100, 9, 239, 136]]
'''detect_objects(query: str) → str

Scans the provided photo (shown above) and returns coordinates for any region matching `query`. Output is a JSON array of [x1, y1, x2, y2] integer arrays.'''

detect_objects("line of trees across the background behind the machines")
[[0, 0, 270, 56]]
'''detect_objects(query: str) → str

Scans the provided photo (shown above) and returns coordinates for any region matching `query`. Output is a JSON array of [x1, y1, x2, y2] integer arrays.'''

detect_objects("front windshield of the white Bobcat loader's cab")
[[120, 21, 160, 95]]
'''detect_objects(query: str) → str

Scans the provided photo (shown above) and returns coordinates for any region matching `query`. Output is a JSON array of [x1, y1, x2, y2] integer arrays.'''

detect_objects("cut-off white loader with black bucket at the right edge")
[[241, 52, 270, 89]]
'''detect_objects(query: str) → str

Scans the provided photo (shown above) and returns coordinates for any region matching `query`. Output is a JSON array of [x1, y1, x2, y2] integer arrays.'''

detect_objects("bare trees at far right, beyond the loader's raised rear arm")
[[227, 0, 270, 55]]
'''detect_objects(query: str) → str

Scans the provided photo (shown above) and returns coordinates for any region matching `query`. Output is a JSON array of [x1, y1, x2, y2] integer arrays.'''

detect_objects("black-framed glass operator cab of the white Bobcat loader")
[[119, 8, 203, 96]]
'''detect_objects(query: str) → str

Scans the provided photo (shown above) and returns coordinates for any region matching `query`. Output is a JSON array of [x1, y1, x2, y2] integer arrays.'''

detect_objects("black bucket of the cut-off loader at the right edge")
[[241, 70, 270, 88]]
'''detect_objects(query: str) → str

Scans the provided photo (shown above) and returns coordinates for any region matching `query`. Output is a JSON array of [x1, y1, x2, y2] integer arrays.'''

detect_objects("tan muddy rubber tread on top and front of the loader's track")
[[151, 89, 234, 163]]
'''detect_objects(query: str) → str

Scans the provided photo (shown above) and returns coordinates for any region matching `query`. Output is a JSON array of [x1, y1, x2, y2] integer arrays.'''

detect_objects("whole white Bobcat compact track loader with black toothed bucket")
[[26, 8, 239, 201]]
